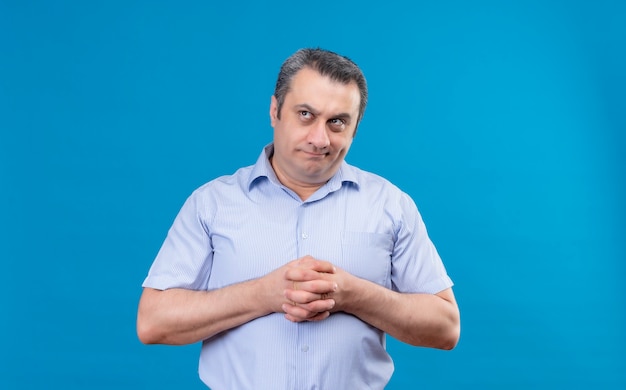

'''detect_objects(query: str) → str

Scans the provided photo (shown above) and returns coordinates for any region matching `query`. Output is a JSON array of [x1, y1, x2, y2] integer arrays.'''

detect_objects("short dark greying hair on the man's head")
[[274, 48, 367, 124]]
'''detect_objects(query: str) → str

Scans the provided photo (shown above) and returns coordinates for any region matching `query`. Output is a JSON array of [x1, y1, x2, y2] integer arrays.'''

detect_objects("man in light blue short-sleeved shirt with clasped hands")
[[137, 49, 460, 390]]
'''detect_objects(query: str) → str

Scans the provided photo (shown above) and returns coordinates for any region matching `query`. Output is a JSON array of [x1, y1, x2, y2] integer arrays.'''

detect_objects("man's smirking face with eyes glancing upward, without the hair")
[[270, 68, 361, 195]]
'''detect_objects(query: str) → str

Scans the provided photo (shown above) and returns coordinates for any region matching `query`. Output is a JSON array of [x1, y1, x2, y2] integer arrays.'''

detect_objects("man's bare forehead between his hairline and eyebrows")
[[285, 67, 361, 117]]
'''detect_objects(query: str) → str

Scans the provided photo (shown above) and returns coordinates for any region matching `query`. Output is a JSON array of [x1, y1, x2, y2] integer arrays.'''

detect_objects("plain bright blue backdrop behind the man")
[[0, 0, 626, 389]]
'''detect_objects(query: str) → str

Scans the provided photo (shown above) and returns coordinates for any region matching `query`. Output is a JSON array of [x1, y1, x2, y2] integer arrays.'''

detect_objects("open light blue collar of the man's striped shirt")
[[248, 143, 359, 192]]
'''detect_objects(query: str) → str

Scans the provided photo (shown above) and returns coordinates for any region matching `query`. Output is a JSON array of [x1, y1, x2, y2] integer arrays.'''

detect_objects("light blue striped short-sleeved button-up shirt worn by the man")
[[143, 145, 452, 390]]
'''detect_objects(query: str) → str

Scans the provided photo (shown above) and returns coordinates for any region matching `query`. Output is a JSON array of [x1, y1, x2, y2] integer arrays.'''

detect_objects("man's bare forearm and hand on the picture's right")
[[285, 269, 461, 349]]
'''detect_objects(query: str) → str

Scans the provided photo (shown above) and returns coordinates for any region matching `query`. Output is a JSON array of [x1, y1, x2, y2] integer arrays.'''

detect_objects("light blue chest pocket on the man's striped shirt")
[[340, 231, 393, 287]]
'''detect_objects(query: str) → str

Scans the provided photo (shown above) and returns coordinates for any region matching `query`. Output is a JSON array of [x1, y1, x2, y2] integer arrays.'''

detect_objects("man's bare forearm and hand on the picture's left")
[[137, 257, 335, 345]]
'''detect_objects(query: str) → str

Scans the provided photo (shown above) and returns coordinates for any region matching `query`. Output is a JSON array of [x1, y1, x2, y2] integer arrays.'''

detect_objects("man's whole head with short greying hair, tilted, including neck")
[[270, 49, 367, 199]]
